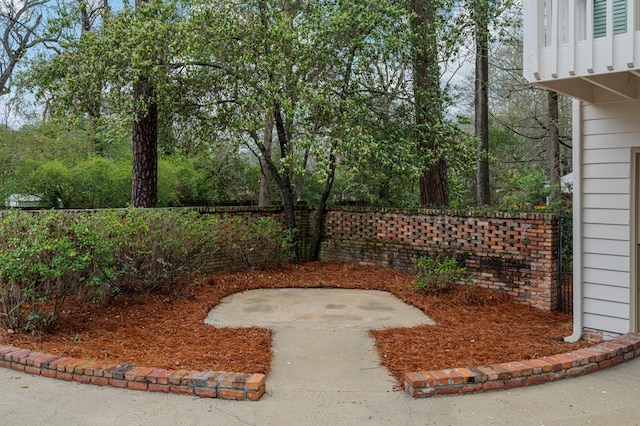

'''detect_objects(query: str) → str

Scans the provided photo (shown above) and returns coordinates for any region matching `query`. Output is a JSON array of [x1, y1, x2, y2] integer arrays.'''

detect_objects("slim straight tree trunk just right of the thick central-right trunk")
[[474, 0, 491, 207]]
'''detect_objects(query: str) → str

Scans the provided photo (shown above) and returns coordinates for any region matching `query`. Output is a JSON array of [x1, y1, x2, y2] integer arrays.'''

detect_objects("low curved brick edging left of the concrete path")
[[0, 345, 266, 401]]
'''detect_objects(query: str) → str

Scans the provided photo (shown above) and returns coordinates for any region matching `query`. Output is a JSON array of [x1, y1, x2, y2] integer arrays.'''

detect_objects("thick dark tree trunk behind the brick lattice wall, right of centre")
[[410, 0, 449, 207]]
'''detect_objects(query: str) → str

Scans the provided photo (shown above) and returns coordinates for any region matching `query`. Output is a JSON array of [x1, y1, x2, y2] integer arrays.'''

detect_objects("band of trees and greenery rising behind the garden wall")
[[0, 0, 570, 220]]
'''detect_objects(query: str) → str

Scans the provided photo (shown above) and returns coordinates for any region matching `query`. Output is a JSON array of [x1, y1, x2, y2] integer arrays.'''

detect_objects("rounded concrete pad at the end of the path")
[[205, 288, 434, 330]]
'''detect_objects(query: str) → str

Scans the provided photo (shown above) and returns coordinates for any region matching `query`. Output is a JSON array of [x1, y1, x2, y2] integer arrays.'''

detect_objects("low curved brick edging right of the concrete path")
[[405, 333, 640, 398]]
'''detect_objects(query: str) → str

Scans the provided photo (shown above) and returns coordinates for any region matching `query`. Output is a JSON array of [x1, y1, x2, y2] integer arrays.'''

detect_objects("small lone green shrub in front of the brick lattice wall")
[[413, 256, 467, 293]]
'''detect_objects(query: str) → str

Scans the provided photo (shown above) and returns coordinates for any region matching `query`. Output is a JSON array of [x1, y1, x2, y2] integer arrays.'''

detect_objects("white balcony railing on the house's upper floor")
[[523, 0, 640, 82]]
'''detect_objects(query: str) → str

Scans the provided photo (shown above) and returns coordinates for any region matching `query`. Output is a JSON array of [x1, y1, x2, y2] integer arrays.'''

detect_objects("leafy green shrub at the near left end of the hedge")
[[0, 212, 113, 331]]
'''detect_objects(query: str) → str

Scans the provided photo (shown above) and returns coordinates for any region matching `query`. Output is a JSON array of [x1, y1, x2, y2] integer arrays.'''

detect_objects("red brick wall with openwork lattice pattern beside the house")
[[321, 208, 559, 310]]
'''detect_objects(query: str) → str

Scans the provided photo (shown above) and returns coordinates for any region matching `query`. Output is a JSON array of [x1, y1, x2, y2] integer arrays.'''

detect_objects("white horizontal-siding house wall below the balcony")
[[574, 102, 640, 337]]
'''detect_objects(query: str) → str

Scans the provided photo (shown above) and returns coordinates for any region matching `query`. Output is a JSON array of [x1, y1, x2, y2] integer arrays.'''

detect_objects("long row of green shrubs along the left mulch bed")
[[0, 209, 288, 331]]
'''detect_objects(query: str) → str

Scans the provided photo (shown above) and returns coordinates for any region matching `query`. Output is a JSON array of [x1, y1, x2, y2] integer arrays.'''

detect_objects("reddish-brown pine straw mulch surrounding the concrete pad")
[[0, 262, 588, 383]]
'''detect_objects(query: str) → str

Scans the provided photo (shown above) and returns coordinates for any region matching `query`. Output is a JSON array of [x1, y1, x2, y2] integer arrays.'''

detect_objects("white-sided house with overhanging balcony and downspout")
[[523, 0, 640, 340]]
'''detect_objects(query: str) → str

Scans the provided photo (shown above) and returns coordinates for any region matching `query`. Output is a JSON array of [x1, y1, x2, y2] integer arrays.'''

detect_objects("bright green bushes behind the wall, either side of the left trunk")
[[0, 124, 259, 208]]
